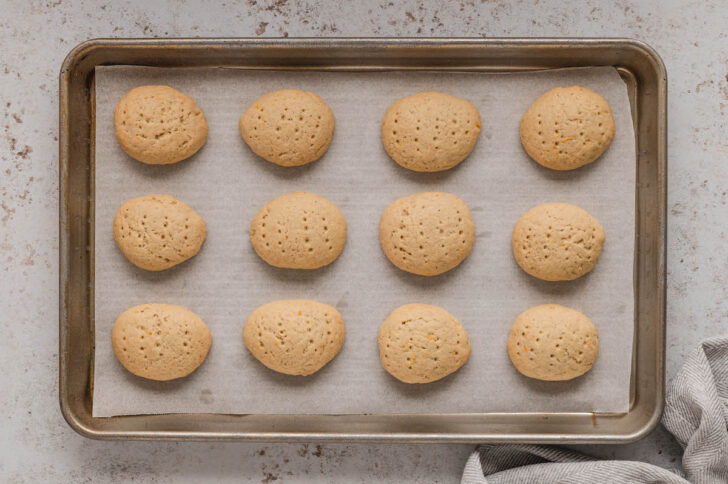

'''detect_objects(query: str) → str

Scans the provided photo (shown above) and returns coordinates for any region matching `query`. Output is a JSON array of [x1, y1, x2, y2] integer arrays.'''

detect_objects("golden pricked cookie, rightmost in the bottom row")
[[508, 304, 599, 381]]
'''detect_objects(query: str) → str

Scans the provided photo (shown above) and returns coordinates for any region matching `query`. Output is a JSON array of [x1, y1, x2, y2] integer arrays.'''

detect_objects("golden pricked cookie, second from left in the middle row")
[[250, 192, 346, 269]]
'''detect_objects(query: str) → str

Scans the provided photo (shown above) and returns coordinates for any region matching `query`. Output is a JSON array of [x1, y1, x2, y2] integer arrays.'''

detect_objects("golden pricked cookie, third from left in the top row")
[[382, 91, 480, 172]]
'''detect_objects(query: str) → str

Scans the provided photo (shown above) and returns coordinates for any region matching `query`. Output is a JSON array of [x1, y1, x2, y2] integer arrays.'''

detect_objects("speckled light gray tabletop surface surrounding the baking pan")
[[0, 0, 728, 482]]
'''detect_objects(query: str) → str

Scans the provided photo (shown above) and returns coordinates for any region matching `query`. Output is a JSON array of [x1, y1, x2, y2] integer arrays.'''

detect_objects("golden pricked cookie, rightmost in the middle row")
[[511, 203, 605, 281]]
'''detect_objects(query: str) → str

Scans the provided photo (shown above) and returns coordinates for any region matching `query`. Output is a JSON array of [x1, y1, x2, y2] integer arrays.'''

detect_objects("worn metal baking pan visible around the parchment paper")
[[59, 38, 667, 443]]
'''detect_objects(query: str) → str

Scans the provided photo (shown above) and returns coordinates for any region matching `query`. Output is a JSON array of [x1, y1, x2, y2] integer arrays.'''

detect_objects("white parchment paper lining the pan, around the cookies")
[[93, 67, 636, 416]]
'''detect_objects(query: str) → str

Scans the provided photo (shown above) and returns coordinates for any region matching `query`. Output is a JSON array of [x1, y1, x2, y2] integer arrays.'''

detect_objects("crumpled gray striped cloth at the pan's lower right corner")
[[461, 336, 728, 484]]
